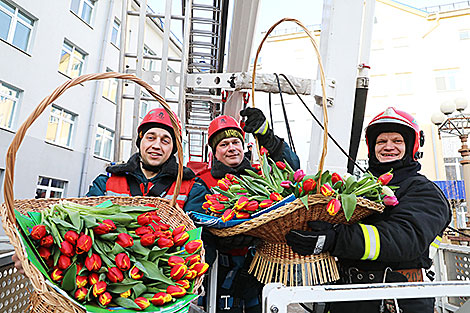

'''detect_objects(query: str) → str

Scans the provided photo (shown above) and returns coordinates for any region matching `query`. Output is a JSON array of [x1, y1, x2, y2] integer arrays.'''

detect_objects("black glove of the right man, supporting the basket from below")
[[286, 221, 336, 255]]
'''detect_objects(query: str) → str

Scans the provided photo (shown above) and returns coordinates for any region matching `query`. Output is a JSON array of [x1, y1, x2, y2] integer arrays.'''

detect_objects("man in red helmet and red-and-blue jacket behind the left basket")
[[87, 108, 209, 211]]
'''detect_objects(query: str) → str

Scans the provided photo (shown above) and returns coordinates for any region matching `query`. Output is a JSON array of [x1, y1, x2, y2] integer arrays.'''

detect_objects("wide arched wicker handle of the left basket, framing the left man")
[[3, 72, 183, 224]]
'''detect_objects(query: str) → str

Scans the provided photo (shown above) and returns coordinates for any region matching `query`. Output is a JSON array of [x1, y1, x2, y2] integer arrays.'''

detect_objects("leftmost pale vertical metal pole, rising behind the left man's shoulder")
[[113, 0, 128, 162]]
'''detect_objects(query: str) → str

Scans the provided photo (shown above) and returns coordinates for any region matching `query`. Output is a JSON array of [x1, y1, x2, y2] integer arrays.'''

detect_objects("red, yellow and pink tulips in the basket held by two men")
[[203, 154, 398, 222]]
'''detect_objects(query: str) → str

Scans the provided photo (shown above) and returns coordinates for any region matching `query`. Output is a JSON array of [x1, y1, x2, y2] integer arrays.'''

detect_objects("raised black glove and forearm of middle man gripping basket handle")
[[240, 108, 284, 161]]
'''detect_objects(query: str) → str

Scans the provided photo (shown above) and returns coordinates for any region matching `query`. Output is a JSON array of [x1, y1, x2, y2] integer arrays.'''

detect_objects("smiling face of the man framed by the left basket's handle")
[[140, 127, 173, 166]]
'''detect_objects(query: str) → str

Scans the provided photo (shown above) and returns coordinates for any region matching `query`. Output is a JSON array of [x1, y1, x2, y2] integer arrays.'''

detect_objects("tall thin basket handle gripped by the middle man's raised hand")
[[251, 17, 328, 178]]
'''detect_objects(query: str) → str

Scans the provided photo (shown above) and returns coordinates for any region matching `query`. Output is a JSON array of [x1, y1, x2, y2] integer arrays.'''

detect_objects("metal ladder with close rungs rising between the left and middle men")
[[185, 0, 228, 162]]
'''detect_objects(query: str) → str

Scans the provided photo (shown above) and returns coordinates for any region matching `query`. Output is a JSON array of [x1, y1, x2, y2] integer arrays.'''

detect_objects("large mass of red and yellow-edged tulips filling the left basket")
[[16, 200, 208, 312]]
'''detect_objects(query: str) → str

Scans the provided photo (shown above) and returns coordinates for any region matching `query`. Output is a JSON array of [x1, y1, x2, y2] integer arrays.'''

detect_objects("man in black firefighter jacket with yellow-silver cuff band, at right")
[[286, 107, 451, 313]]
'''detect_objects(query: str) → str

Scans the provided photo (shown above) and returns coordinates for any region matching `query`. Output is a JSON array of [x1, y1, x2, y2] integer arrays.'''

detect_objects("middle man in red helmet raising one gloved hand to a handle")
[[198, 108, 300, 313]]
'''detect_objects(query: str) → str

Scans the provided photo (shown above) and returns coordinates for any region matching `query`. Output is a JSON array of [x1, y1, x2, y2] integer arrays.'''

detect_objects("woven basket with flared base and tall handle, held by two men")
[[210, 18, 383, 286]]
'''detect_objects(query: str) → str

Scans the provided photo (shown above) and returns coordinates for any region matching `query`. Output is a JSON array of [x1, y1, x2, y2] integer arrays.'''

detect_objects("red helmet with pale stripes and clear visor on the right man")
[[366, 107, 424, 160]]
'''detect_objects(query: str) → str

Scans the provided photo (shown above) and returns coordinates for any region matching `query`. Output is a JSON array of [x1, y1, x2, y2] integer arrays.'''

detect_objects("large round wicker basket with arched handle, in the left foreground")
[[0, 72, 204, 313]]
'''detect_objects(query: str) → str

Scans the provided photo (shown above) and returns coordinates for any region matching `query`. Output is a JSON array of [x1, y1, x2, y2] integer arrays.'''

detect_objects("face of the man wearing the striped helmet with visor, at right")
[[375, 133, 406, 163]]
